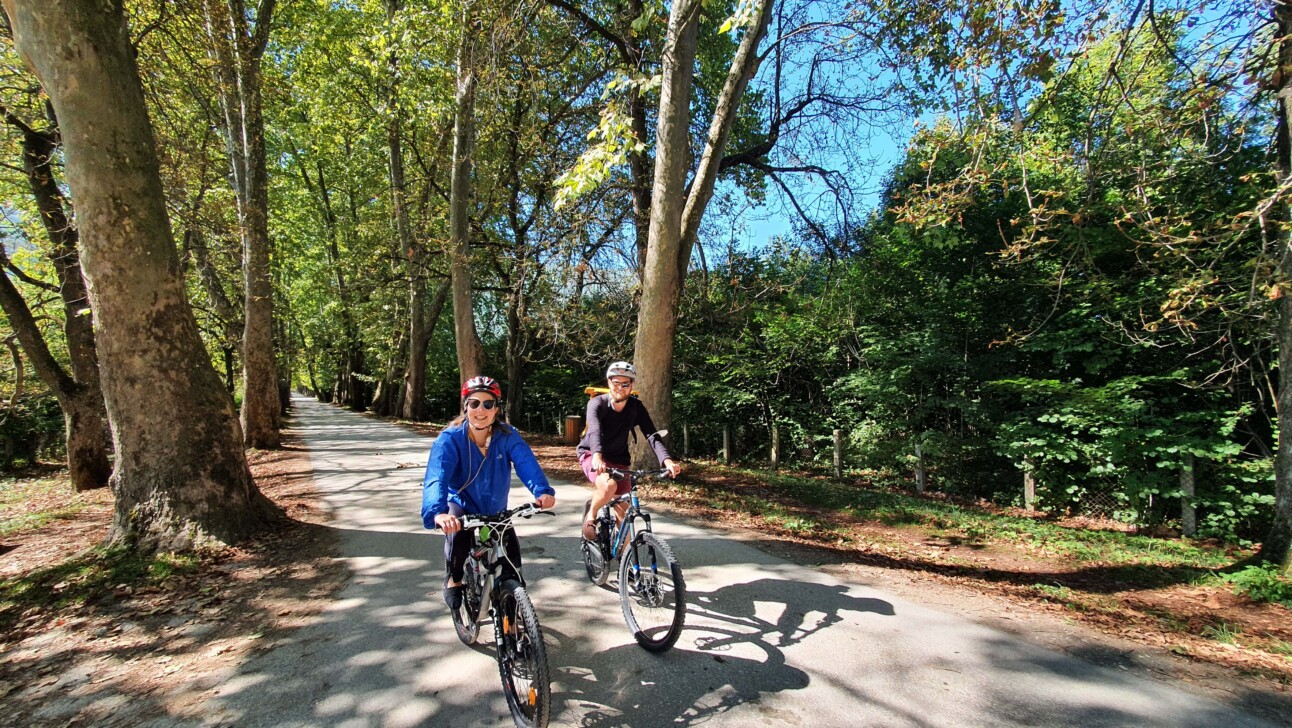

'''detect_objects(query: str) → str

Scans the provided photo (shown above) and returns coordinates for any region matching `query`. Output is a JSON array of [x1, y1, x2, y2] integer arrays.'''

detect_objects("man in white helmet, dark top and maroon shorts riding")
[[578, 362, 682, 541]]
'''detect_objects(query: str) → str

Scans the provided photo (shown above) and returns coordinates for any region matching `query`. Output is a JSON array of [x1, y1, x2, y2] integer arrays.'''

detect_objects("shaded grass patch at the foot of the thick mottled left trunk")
[[0, 548, 203, 630]]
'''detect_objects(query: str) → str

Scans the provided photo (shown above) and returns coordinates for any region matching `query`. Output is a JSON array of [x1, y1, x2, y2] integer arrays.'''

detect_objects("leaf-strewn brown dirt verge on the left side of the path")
[[0, 437, 346, 728]]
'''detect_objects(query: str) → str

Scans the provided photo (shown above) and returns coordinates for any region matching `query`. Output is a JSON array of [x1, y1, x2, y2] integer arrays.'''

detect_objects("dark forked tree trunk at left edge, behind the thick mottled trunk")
[[0, 104, 112, 493]]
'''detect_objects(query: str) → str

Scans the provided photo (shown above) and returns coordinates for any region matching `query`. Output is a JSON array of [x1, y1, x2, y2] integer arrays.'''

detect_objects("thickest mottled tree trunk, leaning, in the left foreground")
[[4, 0, 278, 551]]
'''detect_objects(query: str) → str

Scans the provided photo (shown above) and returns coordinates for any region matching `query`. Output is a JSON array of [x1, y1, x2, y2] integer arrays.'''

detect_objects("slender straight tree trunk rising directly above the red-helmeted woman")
[[448, 8, 485, 381]]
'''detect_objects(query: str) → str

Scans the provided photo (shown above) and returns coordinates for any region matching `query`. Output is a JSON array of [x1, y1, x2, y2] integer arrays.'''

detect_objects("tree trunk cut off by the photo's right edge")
[[1256, 3, 1292, 573]]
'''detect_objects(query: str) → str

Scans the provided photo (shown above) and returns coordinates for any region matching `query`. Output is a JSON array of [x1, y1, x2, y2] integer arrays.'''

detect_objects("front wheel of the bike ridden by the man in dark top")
[[619, 531, 686, 652]]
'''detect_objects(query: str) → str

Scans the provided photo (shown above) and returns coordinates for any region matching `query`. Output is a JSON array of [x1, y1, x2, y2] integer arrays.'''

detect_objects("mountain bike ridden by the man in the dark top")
[[581, 468, 686, 652]]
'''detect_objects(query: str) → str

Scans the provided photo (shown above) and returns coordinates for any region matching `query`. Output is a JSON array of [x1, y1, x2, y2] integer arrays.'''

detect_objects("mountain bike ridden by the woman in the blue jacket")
[[453, 503, 552, 728]]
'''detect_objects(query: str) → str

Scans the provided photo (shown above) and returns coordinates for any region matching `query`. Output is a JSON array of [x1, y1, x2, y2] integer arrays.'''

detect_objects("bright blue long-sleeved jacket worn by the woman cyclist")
[[421, 423, 557, 529]]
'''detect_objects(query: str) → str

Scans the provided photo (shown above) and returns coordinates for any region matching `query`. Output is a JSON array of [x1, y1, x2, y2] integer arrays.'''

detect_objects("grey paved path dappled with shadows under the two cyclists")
[[193, 397, 1271, 728]]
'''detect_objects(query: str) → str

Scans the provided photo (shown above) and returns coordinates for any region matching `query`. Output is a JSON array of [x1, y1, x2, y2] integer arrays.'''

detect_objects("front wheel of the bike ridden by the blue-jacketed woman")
[[495, 579, 552, 728]]
